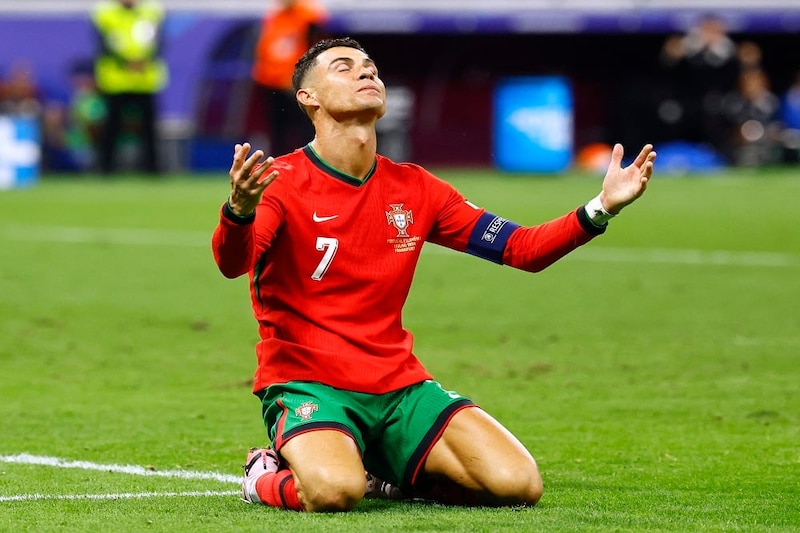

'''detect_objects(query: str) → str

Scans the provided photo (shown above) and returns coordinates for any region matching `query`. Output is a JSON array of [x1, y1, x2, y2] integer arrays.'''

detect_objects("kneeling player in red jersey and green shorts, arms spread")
[[212, 38, 656, 511]]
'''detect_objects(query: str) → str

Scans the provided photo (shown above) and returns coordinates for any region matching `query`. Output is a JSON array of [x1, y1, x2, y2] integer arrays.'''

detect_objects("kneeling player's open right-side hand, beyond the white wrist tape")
[[600, 144, 656, 215]]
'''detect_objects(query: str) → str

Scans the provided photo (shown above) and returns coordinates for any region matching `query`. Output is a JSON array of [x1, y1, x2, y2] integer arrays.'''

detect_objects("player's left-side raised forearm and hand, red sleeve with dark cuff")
[[211, 143, 278, 278]]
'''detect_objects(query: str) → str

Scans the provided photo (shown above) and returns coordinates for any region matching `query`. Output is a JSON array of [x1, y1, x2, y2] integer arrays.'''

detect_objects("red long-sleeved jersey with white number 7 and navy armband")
[[212, 146, 604, 394]]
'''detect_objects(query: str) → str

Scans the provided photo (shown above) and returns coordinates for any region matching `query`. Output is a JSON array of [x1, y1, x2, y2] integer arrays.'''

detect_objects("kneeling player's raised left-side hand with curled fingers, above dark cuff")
[[228, 143, 278, 216]]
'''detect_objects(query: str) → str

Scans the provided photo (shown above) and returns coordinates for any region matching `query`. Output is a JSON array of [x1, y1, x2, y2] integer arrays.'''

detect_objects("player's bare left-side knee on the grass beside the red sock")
[[303, 472, 366, 513]]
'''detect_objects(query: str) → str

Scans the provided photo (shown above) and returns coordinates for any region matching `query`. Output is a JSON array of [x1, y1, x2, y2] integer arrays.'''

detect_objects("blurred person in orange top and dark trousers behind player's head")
[[252, 0, 329, 156]]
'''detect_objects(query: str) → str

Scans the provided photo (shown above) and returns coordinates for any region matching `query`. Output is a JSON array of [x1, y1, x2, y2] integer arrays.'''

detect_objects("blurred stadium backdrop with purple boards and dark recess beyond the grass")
[[0, 0, 800, 181]]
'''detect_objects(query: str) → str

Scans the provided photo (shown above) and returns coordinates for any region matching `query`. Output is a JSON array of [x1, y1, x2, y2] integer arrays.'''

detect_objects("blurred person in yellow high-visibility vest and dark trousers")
[[91, 0, 169, 173]]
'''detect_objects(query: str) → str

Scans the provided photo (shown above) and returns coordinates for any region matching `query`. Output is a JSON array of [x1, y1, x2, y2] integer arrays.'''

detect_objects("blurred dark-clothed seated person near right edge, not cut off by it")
[[723, 67, 782, 167]]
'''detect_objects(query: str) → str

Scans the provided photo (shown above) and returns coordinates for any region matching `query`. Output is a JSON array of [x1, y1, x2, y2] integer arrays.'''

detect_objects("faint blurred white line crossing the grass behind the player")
[[0, 225, 800, 268]]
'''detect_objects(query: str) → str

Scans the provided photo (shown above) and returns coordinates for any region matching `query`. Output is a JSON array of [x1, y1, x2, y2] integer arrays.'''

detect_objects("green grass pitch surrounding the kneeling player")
[[0, 169, 800, 532]]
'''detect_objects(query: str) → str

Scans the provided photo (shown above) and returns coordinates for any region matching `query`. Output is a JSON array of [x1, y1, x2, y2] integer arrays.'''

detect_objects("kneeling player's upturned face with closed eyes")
[[309, 46, 386, 118]]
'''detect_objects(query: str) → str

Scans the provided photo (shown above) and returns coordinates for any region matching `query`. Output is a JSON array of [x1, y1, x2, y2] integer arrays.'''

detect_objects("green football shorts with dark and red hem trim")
[[257, 380, 474, 489]]
